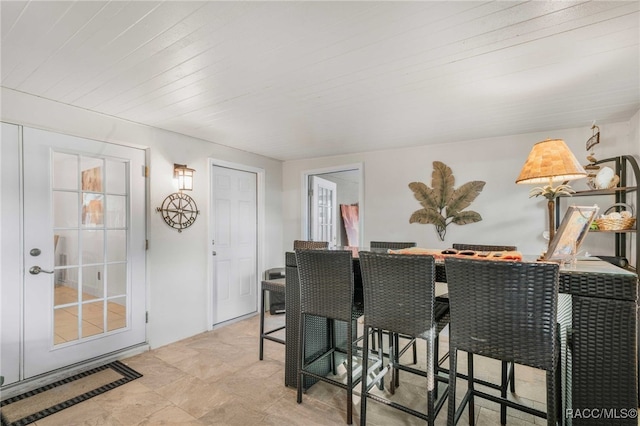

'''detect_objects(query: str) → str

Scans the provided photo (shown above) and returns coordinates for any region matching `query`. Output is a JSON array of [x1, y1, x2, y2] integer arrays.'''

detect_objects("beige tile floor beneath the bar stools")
[[35, 315, 545, 426]]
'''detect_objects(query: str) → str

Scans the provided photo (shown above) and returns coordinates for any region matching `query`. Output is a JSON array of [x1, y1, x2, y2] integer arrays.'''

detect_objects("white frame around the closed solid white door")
[[207, 158, 265, 330]]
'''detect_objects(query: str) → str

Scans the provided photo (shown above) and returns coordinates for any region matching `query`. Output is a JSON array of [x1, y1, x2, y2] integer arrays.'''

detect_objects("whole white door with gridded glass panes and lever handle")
[[23, 128, 145, 378]]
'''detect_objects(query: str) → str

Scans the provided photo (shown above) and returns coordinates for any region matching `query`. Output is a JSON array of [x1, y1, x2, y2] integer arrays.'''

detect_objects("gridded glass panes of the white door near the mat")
[[51, 152, 129, 345]]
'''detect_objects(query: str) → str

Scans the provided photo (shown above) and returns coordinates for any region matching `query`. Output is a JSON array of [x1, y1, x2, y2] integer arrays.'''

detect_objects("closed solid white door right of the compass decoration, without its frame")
[[211, 165, 258, 324]]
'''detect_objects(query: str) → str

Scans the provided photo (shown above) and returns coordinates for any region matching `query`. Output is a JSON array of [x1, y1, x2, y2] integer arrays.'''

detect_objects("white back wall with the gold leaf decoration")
[[283, 114, 640, 264]]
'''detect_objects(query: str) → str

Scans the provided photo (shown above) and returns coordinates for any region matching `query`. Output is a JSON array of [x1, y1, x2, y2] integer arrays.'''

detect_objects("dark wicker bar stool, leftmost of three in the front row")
[[296, 249, 362, 424]]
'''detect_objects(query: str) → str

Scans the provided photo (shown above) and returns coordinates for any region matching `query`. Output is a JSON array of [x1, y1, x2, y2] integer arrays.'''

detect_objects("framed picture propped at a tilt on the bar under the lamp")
[[543, 205, 599, 260]]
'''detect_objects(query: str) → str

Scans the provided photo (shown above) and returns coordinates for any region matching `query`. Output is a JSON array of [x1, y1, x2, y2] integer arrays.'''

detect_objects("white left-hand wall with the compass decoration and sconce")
[[0, 88, 284, 348]]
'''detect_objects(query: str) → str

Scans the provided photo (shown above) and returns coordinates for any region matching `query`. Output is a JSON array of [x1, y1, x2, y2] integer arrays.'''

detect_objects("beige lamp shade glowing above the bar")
[[516, 139, 587, 183]]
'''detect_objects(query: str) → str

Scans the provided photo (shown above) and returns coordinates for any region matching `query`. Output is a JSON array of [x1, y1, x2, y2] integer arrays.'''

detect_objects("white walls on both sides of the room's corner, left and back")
[[0, 82, 640, 347]]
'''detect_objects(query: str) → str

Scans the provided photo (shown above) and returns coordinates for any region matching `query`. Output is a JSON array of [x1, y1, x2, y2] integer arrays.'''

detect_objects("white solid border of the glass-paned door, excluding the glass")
[[23, 127, 147, 378]]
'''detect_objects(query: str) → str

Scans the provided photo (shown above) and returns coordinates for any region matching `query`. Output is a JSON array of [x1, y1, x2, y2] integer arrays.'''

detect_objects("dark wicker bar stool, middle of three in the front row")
[[360, 251, 448, 425]]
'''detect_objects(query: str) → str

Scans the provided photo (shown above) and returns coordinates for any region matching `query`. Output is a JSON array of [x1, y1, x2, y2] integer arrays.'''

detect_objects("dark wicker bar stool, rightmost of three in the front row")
[[445, 258, 562, 425]]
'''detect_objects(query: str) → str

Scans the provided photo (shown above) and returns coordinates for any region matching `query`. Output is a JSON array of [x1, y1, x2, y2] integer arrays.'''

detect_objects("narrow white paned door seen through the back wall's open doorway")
[[309, 176, 339, 246]]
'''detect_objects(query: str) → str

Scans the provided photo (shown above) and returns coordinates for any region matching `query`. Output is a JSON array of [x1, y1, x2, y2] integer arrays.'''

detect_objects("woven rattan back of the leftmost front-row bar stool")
[[296, 249, 353, 321]]
